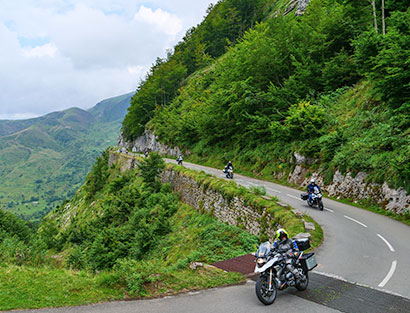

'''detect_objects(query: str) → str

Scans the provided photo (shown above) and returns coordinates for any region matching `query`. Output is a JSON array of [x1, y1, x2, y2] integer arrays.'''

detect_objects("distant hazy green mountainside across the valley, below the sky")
[[0, 93, 133, 220]]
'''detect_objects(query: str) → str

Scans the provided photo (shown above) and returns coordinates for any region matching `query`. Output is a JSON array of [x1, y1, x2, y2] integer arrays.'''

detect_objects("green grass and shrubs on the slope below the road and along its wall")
[[0, 151, 321, 310]]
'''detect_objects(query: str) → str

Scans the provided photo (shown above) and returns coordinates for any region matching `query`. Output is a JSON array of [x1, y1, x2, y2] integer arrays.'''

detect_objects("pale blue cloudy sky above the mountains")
[[0, 0, 217, 119]]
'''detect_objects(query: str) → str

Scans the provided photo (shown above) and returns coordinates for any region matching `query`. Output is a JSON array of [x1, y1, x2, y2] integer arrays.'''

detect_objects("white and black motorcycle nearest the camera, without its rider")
[[255, 238, 317, 305]]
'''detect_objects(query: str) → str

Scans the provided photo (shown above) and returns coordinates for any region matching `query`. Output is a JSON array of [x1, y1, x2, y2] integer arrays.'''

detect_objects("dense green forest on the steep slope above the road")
[[122, 0, 410, 192]]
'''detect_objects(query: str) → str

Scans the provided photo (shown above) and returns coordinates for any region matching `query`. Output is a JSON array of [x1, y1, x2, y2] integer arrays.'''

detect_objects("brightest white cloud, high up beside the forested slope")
[[134, 6, 182, 35]]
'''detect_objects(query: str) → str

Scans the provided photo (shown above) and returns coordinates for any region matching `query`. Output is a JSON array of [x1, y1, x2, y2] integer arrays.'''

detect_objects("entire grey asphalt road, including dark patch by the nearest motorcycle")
[[13, 160, 410, 313]]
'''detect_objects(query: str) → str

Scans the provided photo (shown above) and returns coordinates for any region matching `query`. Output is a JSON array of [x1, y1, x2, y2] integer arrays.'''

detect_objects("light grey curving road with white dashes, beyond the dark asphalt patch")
[[179, 162, 410, 298]]
